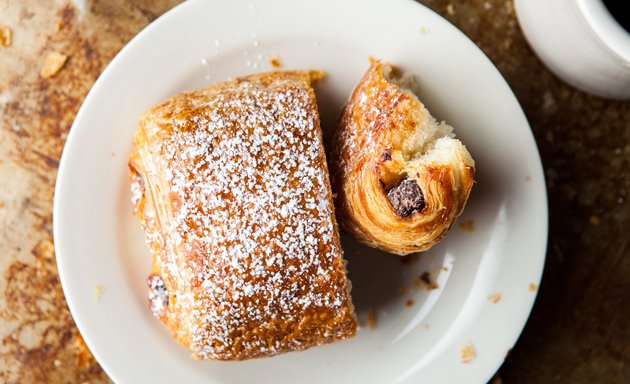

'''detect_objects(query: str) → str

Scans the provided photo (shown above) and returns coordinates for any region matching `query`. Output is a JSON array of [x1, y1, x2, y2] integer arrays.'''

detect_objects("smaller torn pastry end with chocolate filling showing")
[[331, 61, 475, 255]]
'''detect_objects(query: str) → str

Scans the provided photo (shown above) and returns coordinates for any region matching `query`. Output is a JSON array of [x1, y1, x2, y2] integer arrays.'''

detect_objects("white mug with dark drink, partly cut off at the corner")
[[514, 0, 630, 100]]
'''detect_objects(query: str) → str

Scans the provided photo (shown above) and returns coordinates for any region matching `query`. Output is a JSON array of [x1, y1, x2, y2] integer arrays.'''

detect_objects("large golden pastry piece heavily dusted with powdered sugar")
[[129, 71, 357, 360]]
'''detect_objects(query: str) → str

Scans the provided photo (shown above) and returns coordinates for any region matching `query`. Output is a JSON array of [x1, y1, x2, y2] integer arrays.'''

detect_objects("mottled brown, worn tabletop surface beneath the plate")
[[0, 0, 630, 383]]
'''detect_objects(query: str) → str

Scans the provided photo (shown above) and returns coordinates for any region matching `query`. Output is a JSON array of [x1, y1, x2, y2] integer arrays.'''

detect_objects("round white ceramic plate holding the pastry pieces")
[[54, 0, 547, 384]]
